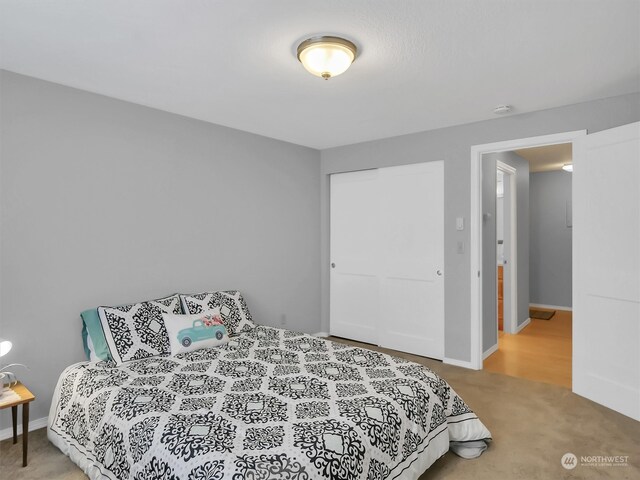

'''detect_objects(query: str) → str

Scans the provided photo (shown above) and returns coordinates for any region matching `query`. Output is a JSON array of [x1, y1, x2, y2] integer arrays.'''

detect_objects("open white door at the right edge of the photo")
[[572, 123, 640, 420]]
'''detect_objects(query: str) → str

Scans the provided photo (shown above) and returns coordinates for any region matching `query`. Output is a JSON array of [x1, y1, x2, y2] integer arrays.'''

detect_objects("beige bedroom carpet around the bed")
[[0, 342, 640, 480]]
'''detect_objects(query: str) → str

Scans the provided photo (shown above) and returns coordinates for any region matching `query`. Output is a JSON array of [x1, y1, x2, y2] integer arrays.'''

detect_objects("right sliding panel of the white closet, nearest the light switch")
[[379, 162, 444, 359]]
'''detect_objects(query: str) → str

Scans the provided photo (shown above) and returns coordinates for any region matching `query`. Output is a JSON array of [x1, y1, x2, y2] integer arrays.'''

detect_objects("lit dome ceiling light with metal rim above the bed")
[[298, 36, 358, 80]]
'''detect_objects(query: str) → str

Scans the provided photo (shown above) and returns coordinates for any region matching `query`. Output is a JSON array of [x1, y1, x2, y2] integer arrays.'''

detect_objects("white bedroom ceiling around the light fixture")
[[0, 0, 640, 148]]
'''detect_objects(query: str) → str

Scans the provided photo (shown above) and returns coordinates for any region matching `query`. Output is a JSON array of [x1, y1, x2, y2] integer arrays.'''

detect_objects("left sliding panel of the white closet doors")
[[329, 170, 380, 345]]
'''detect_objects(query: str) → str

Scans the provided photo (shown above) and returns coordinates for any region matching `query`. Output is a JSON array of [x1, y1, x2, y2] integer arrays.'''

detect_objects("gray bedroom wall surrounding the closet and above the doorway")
[[321, 92, 640, 361]]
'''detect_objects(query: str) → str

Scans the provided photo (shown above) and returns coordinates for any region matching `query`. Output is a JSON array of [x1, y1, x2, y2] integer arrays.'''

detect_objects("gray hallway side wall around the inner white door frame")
[[482, 152, 529, 352]]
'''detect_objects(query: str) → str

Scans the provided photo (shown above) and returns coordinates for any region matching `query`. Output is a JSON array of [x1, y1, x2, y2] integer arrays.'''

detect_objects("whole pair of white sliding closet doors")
[[330, 162, 444, 358]]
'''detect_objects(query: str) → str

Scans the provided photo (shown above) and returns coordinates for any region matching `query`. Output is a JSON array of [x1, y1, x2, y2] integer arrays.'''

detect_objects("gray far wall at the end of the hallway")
[[529, 170, 576, 307]]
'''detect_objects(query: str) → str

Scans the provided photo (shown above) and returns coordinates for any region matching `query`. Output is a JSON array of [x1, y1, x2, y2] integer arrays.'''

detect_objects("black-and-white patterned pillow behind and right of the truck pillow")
[[180, 290, 256, 335]]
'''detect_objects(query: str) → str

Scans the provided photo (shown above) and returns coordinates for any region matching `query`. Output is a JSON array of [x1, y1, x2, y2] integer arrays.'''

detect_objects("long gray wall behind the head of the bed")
[[0, 72, 320, 428]]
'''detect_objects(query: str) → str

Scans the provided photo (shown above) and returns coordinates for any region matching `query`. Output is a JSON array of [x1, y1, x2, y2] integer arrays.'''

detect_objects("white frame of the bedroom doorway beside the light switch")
[[469, 130, 587, 370]]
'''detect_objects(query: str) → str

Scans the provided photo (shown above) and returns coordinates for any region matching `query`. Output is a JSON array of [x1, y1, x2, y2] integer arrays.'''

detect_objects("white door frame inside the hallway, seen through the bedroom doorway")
[[496, 160, 518, 336]]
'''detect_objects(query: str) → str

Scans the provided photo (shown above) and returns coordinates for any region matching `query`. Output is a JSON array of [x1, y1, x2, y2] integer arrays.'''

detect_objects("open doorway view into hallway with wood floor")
[[481, 137, 572, 388]]
